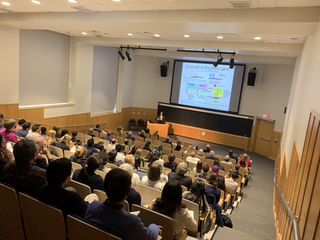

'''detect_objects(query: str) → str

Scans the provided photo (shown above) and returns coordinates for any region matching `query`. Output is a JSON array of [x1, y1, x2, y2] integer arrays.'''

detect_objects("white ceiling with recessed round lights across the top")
[[0, 0, 320, 62]]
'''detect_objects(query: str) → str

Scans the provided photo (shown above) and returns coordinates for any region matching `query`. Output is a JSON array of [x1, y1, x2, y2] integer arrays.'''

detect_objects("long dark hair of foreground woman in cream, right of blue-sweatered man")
[[153, 179, 185, 217]]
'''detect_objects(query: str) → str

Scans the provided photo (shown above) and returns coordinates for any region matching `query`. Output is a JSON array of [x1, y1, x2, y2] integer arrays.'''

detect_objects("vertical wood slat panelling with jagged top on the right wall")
[[273, 111, 320, 240]]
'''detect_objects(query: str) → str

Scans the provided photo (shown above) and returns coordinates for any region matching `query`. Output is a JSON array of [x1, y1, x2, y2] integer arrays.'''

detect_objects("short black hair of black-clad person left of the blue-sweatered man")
[[46, 158, 72, 186]]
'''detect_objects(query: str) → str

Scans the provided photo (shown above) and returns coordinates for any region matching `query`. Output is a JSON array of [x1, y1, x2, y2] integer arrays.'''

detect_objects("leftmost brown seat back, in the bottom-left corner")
[[0, 183, 25, 240]]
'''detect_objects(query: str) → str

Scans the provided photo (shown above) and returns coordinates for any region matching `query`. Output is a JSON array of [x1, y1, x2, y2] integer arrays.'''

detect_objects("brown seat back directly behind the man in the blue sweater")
[[67, 215, 120, 240]]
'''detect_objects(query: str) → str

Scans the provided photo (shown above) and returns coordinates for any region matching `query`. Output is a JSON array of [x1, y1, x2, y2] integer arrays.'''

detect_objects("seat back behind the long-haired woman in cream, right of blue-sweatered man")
[[131, 204, 174, 240]]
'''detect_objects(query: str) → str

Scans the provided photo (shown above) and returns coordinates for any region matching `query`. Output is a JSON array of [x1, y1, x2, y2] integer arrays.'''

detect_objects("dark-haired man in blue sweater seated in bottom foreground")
[[85, 168, 159, 240]]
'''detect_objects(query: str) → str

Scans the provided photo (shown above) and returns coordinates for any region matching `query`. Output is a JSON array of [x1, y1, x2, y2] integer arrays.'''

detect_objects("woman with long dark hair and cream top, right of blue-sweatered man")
[[151, 180, 197, 235]]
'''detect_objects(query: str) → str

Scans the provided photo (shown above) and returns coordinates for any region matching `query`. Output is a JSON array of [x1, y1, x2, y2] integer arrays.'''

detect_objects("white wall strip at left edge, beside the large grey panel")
[[0, 27, 19, 104]]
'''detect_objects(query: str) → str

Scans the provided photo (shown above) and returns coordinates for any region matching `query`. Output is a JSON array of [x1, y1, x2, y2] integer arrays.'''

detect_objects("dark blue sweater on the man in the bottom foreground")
[[85, 201, 159, 240]]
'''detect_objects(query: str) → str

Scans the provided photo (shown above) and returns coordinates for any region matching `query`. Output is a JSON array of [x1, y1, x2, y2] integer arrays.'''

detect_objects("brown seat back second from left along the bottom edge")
[[19, 193, 67, 240]]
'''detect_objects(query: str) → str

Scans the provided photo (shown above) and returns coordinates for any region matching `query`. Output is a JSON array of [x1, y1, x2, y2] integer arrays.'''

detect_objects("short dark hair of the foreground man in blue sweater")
[[104, 168, 131, 203]]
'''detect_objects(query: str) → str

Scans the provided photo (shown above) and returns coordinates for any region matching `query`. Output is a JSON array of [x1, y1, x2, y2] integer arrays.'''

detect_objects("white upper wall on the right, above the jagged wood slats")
[[282, 23, 320, 161]]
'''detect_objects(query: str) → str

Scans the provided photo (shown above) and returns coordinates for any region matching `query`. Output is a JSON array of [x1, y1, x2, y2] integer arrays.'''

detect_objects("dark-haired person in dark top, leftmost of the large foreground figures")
[[0, 139, 46, 196]]
